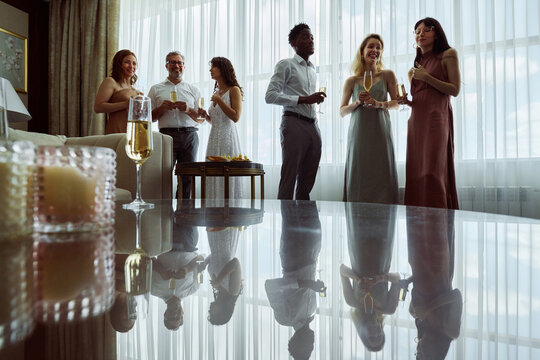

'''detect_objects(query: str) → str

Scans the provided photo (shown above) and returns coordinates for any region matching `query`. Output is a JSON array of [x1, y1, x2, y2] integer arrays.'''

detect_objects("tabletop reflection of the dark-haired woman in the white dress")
[[205, 227, 242, 325]]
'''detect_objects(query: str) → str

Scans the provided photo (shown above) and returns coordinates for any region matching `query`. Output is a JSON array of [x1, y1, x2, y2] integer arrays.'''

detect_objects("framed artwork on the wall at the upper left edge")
[[0, 28, 28, 93]]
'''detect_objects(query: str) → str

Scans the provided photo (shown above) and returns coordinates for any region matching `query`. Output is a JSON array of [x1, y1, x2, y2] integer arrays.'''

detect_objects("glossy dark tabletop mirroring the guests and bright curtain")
[[0, 200, 540, 360]]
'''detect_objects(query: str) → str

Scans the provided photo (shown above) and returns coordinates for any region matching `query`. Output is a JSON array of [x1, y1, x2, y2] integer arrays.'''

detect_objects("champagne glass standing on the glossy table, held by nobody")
[[122, 95, 154, 209]]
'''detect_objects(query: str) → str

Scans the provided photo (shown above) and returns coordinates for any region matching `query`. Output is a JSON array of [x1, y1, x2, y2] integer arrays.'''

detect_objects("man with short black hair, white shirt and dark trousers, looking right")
[[265, 23, 326, 200]]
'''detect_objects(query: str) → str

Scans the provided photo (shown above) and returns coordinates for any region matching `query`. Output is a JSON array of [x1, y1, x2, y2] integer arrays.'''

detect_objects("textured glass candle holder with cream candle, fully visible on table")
[[34, 146, 116, 232]]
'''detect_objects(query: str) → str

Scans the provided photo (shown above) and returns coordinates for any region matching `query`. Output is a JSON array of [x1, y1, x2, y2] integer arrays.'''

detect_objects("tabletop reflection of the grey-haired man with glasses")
[[151, 224, 204, 330]]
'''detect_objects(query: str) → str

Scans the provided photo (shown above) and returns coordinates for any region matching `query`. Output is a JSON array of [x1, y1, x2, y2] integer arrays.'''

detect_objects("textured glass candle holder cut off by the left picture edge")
[[0, 140, 36, 241]]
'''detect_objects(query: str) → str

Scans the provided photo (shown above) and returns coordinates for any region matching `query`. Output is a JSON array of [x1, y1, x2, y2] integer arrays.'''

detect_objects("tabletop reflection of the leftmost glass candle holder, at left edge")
[[0, 235, 35, 353]]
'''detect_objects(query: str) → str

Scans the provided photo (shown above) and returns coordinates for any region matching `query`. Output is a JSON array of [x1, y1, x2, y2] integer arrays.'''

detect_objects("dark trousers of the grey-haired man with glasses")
[[159, 127, 199, 199]]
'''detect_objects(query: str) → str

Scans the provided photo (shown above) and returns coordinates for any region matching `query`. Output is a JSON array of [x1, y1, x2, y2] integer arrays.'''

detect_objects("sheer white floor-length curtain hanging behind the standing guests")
[[119, 0, 540, 217]]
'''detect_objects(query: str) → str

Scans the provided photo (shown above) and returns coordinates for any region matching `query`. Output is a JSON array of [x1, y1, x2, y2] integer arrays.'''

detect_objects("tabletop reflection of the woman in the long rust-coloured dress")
[[407, 208, 463, 359]]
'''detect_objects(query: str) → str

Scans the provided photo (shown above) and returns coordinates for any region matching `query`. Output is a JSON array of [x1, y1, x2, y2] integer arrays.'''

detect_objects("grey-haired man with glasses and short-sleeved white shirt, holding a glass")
[[148, 51, 204, 199]]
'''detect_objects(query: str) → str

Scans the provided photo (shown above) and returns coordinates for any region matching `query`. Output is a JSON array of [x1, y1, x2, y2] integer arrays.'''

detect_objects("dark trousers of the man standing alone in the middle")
[[278, 115, 322, 200]]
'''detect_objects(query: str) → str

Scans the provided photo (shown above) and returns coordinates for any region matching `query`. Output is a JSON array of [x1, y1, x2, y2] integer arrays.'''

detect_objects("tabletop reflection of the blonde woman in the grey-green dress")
[[340, 203, 401, 351]]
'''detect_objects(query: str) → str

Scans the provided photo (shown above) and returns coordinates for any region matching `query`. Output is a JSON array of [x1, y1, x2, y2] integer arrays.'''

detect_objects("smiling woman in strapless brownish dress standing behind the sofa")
[[94, 50, 138, 134]]
